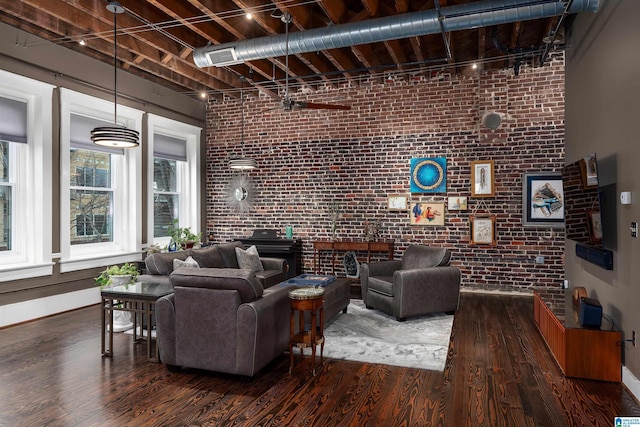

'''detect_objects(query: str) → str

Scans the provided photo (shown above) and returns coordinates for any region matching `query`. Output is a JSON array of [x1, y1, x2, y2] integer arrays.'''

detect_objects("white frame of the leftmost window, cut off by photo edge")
[[0, 70, 55, 282]]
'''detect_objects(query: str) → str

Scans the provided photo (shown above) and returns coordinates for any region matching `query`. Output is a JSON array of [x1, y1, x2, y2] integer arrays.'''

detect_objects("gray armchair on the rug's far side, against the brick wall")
[[360, 245, 460, 321]]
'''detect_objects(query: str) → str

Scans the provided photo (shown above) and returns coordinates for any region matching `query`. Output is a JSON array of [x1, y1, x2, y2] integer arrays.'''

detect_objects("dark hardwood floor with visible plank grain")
[[0, 293, 640, 427]]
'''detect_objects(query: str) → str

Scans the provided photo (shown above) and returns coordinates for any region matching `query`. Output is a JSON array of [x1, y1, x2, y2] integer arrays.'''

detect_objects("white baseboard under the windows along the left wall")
[[0, 286, 100, 328]]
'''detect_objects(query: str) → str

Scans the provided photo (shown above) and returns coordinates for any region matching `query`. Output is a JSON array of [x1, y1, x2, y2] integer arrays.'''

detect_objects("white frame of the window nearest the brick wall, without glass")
[[147, 114, 202, 246]]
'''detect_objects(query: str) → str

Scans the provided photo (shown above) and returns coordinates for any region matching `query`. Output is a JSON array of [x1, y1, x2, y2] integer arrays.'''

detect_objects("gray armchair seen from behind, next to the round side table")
[[156, 267, 289, 377]]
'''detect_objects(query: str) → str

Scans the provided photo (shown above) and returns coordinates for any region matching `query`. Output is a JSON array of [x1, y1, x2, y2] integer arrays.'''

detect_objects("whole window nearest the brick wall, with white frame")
[[148, 114, 201, 245]]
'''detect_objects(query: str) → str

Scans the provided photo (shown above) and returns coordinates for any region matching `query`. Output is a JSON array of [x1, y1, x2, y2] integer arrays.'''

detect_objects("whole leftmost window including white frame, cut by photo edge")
[[0, 71, 53, 281]]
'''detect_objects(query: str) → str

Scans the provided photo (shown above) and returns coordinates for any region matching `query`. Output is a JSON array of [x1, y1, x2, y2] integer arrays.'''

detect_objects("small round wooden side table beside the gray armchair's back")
[[289, 287, 324, 376]]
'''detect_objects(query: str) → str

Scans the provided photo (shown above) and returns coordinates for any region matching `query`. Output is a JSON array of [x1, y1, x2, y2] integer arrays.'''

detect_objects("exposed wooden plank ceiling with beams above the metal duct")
[[0, 0, 559, 97]]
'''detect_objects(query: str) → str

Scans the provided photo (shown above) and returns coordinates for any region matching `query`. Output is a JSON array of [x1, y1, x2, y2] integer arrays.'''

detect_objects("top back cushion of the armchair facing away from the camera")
[[169, 267, 264, 302]]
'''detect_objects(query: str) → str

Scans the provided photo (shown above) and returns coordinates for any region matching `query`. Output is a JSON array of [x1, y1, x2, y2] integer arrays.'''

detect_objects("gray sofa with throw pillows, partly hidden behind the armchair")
[[138, 242, 289, 288]]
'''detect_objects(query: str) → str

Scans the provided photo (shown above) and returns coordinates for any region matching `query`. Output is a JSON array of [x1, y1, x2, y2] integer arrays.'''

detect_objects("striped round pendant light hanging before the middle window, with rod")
[[91, 1, 140, 148]]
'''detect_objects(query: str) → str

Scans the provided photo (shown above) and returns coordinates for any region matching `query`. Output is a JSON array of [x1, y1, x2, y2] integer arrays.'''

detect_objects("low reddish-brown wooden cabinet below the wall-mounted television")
[[533, 292, 622, 382]]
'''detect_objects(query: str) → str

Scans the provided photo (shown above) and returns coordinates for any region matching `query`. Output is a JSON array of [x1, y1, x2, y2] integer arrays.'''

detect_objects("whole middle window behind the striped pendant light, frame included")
[[60, 89, 142, 272]]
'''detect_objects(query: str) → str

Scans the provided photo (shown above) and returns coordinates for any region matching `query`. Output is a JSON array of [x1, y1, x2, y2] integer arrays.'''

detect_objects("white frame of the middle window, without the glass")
[[60, 88, 143, 273]]
